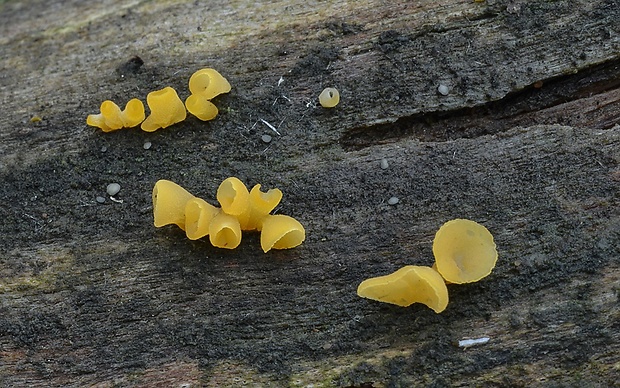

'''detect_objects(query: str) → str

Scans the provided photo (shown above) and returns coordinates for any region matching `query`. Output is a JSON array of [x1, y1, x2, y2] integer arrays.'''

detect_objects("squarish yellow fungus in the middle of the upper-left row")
[[141, 86, 187, 132]]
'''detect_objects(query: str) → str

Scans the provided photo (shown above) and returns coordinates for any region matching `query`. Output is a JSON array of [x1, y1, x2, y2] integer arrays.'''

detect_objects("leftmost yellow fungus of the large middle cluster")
[[153, 179, 194, 230]]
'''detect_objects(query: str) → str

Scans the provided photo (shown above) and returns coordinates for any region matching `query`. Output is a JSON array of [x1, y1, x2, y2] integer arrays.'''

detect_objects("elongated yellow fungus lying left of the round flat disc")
[[357, 265, 448, 313]]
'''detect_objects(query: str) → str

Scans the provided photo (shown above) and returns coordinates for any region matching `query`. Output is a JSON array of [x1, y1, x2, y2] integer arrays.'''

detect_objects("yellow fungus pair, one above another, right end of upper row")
[[185, 68, 230, 121]]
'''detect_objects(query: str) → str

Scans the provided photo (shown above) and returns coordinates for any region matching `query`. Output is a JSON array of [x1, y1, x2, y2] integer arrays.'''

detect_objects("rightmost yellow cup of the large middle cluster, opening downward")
[[260, 214, 306, 253]]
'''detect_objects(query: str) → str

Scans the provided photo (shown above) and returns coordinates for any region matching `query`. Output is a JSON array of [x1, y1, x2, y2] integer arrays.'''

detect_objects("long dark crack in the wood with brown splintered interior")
[[340, 59, 620, 151]]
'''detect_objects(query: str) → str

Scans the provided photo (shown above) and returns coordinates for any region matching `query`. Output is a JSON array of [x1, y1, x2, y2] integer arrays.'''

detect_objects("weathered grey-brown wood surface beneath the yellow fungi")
[[0, 0, 620, 387]]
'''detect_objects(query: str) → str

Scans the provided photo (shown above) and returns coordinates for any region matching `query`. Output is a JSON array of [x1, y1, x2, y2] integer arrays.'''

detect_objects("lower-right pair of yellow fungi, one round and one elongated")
[[357, 219, 497, 313]]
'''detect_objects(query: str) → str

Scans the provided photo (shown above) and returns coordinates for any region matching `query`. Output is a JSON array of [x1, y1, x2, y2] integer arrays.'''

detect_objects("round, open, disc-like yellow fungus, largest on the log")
[[433, 219, 497, 284]]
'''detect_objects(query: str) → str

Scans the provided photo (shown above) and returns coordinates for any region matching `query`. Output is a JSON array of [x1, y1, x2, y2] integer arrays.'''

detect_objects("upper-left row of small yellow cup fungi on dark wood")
[[86, 68, 230, 132]]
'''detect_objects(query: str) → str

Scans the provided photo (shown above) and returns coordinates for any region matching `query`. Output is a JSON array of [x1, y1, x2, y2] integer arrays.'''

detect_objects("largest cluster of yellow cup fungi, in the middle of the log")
[[153, 177, 306, 253]]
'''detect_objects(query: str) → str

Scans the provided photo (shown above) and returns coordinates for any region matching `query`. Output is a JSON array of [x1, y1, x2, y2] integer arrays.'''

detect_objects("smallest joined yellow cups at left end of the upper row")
[[86, 98, 145, 132]]
